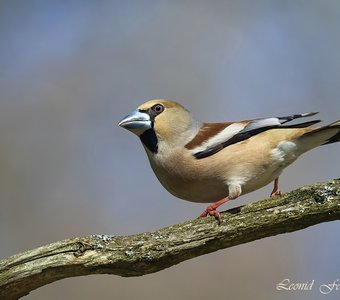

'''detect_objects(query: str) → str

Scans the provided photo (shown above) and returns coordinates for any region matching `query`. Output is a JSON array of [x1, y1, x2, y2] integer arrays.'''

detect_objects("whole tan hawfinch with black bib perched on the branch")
[[119, 100, 340, 223]]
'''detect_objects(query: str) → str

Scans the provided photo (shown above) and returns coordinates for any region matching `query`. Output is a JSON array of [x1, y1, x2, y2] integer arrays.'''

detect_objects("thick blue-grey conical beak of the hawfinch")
[[118, 110, 152, 136]]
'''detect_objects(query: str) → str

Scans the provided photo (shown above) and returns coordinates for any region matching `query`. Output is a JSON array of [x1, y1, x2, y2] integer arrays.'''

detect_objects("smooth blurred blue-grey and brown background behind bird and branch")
[[0, 0, 340, 300]]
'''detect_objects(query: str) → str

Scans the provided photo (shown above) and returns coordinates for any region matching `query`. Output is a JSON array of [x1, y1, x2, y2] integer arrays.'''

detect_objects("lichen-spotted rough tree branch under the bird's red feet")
[[0, 179, 340, 300]]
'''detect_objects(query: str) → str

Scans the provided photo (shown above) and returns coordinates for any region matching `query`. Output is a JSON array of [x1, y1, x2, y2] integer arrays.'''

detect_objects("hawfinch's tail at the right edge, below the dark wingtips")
[[299, 120, 340, 151]]
